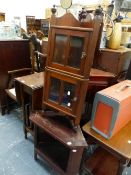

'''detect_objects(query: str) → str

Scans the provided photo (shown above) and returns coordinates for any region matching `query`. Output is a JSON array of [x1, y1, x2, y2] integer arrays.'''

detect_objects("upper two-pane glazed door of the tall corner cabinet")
[[47, 28, 92, 76]]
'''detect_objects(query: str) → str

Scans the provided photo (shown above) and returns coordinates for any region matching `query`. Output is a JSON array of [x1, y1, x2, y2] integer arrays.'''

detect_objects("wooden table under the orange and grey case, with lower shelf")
[[82, 121, 131, 175]]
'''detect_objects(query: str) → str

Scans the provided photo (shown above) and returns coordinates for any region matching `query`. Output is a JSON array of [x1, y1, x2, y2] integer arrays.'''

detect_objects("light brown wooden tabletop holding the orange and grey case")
[[82, 121, 131, 160]]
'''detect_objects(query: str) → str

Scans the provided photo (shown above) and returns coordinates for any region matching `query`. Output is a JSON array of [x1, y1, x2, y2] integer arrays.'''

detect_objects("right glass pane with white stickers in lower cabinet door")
[[61, 82, 75, 108]]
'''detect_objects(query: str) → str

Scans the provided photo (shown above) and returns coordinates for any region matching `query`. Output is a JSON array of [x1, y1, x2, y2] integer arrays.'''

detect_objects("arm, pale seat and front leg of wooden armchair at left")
[[5, 68, 31, 113]]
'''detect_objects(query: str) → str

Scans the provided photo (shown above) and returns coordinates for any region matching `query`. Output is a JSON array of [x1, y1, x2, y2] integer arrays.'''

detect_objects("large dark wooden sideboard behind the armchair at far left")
[[0, 40, 31, 114]]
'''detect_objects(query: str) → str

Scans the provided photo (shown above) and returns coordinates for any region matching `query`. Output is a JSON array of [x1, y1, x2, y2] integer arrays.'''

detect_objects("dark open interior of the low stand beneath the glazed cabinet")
[[35, 133, 70, 172]]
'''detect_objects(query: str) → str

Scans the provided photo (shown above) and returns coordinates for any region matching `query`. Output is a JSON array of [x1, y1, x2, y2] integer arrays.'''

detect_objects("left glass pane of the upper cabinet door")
[[53, 35, 67, 64]]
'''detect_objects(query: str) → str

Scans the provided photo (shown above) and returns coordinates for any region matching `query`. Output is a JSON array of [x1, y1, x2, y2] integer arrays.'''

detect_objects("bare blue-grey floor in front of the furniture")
[[0, 110, 56, 175]]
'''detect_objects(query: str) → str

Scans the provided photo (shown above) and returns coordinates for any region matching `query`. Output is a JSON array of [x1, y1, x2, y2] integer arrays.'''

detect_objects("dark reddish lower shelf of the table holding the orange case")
[[81, 145, 119, 175]]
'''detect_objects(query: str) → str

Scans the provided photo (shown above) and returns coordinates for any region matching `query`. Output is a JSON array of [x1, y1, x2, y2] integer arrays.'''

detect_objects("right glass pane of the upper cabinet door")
[[68, 36, 84, 68]]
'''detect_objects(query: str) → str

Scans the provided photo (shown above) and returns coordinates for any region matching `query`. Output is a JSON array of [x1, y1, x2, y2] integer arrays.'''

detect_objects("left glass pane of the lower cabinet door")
[[49, 78, 60, 102]]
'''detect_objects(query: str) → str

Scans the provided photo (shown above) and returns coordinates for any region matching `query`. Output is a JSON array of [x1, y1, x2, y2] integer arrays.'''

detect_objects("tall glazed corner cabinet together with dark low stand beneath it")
[[30, 13, 102, 175]]
